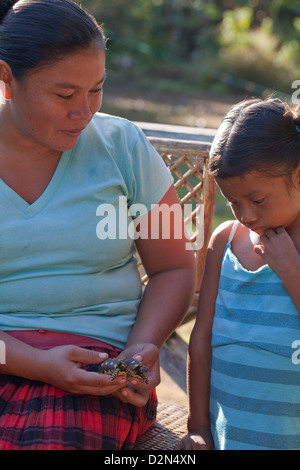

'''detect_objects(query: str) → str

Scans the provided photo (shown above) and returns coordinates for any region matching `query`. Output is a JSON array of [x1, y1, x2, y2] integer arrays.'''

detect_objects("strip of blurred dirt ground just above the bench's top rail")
[[101, 77, 246, 129]]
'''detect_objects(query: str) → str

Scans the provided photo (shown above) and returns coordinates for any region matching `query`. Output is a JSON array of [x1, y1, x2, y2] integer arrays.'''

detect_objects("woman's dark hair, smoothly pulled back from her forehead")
[[0, 0, 106, 79]]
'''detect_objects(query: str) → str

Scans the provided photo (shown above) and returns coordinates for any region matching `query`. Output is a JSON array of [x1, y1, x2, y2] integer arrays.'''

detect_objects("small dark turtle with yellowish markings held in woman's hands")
[[98, 357, 148, 384]]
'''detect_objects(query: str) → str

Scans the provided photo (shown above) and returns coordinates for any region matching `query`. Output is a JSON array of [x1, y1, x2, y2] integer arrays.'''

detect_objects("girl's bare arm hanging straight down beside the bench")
[[177, 222, 232, 450]]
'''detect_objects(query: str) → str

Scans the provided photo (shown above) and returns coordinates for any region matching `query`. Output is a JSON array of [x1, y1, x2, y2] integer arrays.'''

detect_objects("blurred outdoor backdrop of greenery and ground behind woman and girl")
[[80, 0, 300, 228]]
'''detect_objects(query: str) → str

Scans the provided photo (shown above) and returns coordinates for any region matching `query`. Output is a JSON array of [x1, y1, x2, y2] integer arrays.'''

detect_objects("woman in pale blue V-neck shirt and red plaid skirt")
[[0, 0, 195, 450]]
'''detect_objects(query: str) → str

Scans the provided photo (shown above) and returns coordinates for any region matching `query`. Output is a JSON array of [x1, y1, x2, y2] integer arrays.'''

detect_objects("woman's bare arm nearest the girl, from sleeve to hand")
[[117, 186, 196, 404]]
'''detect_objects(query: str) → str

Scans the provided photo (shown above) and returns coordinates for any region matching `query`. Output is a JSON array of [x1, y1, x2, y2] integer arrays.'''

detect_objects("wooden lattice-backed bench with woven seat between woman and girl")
[[135, 122, 216, 450]]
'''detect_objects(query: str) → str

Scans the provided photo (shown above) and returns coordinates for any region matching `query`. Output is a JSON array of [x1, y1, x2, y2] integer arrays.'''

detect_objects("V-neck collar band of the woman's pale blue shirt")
[[0, 149, 73, 217]]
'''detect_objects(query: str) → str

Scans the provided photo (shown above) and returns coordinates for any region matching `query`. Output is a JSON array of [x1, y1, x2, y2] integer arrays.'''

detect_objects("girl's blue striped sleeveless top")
[[210, 224, 300, 450]]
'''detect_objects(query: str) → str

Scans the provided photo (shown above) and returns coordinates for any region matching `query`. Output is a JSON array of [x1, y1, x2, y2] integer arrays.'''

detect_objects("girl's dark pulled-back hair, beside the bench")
[[210, 98, 300, 178]]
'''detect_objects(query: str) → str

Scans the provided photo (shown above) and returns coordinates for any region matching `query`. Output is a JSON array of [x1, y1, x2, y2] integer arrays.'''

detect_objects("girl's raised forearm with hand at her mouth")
[[254, 227, 300, 315]]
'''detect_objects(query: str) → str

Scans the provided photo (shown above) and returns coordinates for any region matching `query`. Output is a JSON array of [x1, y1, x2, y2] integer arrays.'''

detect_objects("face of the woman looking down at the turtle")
[[6, 46, 105, 151]]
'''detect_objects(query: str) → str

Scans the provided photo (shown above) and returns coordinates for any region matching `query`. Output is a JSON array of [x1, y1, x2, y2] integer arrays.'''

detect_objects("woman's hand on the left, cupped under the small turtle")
[[36, 346, 127, 396]]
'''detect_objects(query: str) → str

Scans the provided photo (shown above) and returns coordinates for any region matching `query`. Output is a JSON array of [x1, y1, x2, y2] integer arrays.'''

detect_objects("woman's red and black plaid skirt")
[[0, 332, 157, 450]]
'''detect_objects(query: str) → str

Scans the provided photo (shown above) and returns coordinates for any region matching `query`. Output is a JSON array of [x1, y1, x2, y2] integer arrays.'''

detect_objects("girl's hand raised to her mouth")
[[254, 227, 299, 280]]
